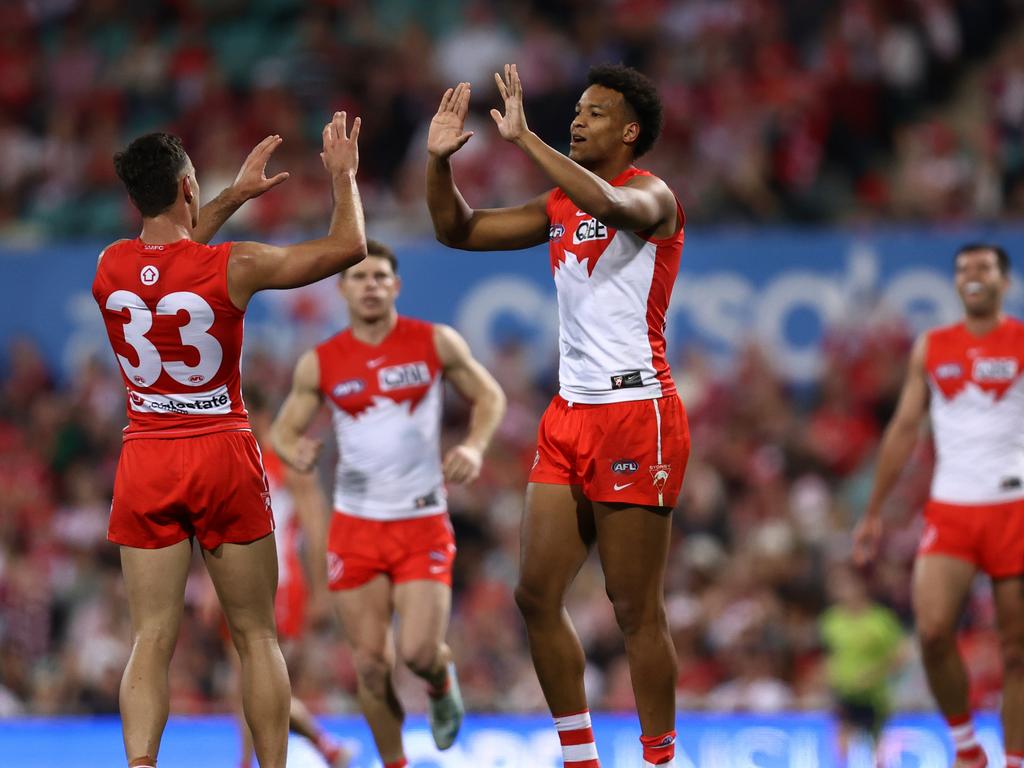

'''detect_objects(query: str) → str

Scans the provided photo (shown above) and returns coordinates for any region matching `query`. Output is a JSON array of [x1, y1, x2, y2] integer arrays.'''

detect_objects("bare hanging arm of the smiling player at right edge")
[[853, 335, 928, 565]]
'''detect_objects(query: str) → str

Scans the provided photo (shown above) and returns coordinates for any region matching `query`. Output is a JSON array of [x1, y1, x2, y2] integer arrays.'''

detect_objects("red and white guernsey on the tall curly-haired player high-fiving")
[[548, 168, 684, 402]]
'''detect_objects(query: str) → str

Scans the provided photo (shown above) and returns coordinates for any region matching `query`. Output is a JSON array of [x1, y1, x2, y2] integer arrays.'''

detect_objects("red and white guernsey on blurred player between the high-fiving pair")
[[316, 316, 447, 520]]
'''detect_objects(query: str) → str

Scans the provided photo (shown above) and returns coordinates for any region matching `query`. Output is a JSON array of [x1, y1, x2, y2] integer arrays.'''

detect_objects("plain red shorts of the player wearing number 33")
[[106, 431, 273, 550]]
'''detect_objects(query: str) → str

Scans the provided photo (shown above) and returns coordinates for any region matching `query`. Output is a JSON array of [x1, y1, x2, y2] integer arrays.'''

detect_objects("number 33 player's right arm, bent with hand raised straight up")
[[227, 112, 367, 308]]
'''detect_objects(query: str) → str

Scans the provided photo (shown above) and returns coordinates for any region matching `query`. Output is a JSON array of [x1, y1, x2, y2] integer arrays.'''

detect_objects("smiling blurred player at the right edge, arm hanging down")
[[854, 244, 1024, 768]]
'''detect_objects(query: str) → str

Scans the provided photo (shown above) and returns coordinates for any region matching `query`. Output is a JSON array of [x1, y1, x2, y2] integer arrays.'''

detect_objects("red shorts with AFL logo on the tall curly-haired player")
[[529, 395, 690, 507]]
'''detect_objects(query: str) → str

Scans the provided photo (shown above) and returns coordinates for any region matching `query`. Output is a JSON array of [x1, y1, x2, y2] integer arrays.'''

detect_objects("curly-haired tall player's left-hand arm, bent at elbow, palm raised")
[[427, 83, 549, 251]]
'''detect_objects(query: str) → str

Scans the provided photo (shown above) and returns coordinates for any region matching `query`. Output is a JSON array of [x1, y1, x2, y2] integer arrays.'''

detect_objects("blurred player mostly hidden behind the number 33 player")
[[228, 389, 349, 768]]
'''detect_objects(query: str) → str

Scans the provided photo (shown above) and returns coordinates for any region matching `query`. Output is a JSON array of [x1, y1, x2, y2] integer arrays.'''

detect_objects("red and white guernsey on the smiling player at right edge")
[[925, 317, 1024, 504]]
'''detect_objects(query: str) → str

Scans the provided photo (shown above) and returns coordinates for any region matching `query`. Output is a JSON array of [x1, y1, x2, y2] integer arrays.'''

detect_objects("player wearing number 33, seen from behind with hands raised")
[[92, 113, 366, 768]]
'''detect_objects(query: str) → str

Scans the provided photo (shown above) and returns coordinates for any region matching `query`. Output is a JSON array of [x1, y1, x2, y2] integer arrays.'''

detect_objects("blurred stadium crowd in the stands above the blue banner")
[[0, 0, 1024, 242]]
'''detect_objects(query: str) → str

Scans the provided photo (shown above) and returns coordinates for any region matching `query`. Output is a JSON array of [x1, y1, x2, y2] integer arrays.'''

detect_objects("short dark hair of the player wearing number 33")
[[114, 133, 188, 218]]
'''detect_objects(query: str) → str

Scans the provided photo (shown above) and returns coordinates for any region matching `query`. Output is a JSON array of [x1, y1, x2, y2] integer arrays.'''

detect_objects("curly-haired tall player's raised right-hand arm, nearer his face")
[[490, 65, 681, 232]]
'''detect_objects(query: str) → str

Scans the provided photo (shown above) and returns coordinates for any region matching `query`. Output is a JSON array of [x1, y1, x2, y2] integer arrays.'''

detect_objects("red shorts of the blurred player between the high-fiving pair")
[[327, 512, 456, 590]]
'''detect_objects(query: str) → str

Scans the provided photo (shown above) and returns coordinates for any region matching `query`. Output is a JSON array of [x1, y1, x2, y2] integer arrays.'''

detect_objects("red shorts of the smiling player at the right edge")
[[918, 500, 1024, 579]]
